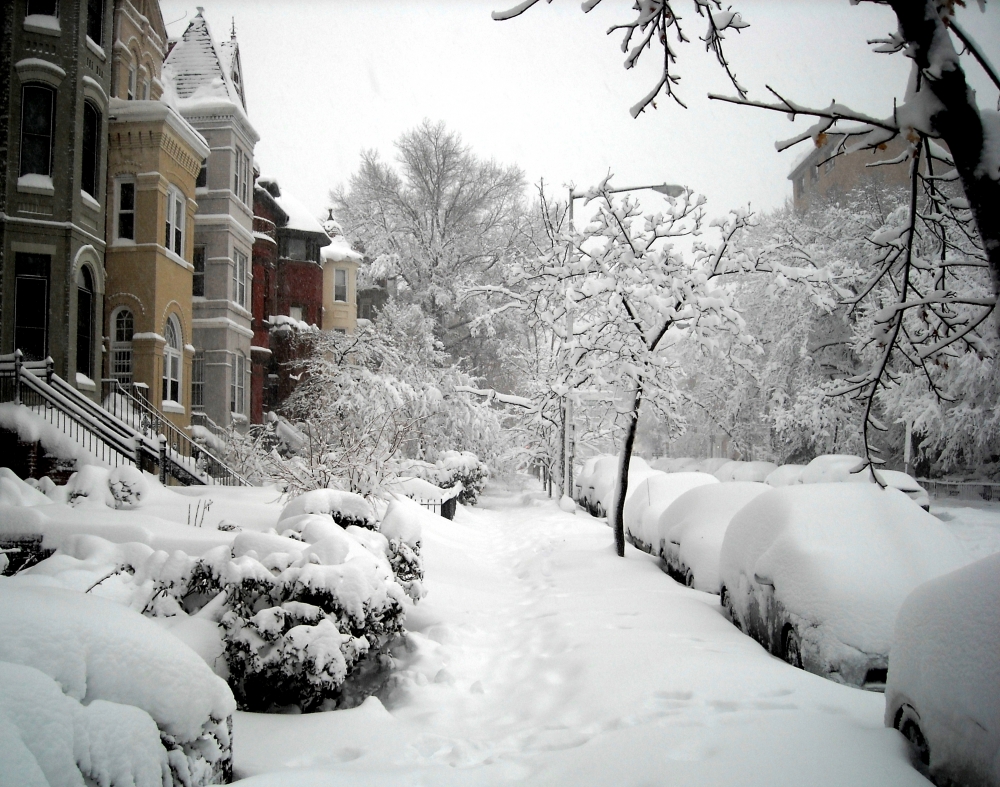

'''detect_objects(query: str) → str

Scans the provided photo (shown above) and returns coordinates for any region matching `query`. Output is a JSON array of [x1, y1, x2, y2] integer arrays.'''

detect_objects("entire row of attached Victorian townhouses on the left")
[[0, 0, 361, 438]]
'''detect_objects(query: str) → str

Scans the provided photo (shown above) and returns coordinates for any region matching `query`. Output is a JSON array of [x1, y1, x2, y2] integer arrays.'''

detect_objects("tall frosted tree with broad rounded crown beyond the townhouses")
[[330, 120, 525, 384]]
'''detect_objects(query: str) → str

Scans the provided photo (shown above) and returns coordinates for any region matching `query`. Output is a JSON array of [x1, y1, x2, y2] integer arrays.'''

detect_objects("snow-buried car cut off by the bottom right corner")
[[885, 554, 1000, 787]]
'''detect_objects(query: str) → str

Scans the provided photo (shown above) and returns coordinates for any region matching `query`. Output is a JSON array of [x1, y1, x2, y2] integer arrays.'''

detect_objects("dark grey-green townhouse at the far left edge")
[[0, 0, 114, 398]]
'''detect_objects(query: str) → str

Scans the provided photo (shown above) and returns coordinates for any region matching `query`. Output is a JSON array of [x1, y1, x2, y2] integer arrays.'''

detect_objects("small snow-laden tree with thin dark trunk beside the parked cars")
[[476, 181, 827, 555]]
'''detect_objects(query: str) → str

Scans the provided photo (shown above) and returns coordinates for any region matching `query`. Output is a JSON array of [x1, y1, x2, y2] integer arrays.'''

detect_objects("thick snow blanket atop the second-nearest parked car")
[[719, 483, 969, 653]]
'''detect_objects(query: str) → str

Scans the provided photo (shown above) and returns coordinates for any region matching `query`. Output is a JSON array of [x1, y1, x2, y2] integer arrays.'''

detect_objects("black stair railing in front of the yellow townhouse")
[[101, 379, 249, 486]]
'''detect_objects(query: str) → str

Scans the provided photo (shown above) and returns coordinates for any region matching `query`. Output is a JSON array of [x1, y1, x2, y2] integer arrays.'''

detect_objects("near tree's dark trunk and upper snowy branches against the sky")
[[493, 0, 1000, 304]]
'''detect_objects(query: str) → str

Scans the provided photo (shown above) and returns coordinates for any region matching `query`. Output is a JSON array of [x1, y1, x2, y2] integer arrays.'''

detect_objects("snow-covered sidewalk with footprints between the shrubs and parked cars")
[[234, 493, 928, 787]]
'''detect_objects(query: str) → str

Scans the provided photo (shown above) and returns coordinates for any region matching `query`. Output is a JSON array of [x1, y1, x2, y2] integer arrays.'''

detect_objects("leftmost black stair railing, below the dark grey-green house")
[[0, 351, 147, 467]]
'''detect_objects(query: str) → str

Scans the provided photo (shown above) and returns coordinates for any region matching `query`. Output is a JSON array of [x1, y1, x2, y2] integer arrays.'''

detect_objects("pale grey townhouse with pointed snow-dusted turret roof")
[[164, 9, 259, 427]]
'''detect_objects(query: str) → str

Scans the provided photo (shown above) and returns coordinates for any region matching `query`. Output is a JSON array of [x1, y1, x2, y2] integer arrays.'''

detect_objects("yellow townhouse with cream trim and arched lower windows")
[[104, 0, 209, 427]]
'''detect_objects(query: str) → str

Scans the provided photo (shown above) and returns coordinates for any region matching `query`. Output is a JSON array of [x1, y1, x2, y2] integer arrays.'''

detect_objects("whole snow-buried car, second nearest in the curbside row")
[[719, 483, 968, 688]]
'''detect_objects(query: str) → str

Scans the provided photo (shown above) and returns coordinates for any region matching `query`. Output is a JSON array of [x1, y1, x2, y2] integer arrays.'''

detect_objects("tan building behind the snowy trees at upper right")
[[788, 134, 910, 213]]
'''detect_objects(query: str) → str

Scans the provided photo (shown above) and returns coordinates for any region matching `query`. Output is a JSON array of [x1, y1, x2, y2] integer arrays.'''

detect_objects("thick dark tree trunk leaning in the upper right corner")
[[890, 0, 1000, 308]]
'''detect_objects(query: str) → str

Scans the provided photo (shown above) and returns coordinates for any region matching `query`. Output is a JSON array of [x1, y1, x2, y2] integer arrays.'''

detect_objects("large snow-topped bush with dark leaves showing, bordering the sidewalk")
[[136, 528, 404, 711]]
